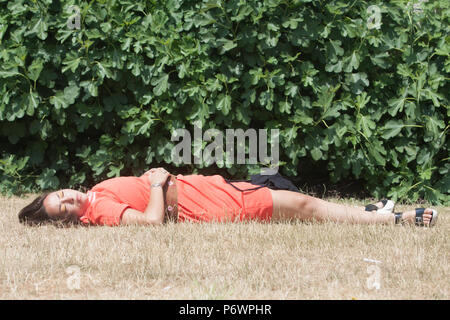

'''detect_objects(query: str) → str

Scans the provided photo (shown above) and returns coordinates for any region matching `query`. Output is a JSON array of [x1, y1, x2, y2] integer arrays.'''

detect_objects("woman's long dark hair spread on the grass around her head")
[[19, 193, 81, 226]]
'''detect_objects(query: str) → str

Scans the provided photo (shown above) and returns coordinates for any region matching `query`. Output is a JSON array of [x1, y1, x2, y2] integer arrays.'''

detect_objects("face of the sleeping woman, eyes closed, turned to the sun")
[[44, 189, 89, 220]]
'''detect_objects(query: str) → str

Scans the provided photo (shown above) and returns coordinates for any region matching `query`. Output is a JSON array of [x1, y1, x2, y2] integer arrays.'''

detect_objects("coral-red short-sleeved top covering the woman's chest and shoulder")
[[80, 176, 150, 226]]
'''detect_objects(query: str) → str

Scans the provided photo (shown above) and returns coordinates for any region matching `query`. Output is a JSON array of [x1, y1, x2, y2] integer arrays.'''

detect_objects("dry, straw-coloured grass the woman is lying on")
[[0, 196, 450, 299]]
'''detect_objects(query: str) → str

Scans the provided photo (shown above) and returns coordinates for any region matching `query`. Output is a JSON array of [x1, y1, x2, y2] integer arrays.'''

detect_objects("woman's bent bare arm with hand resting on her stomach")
[[121, 168, 169, 225]]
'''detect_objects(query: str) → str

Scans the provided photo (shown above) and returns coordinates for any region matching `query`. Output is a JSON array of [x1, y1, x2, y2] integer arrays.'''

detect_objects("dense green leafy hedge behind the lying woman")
[[0, 0, 450, 203]]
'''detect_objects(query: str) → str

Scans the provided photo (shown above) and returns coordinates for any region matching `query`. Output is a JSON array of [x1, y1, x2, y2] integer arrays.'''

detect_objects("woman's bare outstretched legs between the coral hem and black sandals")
[[270, 189, 431, 224]]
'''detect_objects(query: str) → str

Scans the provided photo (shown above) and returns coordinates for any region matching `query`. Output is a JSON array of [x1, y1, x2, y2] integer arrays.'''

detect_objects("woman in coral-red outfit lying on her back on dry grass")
[[19, 168, 437, 226]]
